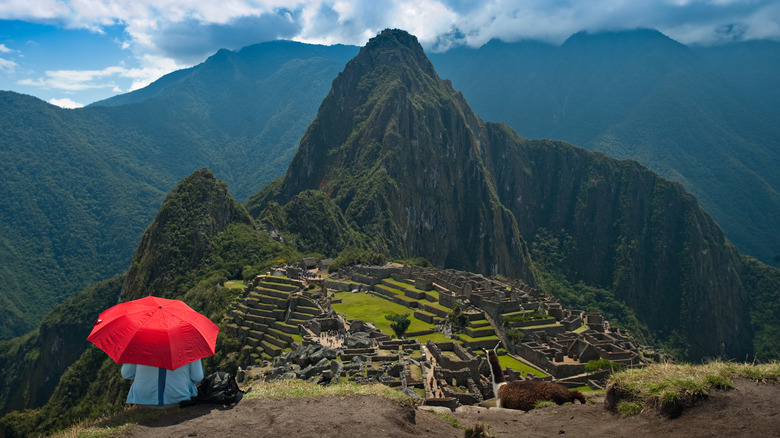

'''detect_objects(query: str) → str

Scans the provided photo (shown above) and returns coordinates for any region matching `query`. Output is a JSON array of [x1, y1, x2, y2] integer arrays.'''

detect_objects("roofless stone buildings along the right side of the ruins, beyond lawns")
[[394, 266, 647, 379]]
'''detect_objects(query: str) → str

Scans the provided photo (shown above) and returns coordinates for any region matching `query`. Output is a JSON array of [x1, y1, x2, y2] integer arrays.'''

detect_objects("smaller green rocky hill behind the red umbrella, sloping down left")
[[0, 169, 300, 436]]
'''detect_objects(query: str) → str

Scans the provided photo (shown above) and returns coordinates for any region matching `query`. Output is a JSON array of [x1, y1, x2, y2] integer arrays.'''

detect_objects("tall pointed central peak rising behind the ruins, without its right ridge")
[[249, 30, 534, 283]]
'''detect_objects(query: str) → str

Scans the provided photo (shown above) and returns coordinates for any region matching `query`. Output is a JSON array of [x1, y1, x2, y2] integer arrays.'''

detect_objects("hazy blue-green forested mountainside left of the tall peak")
[[0, 41, 357, 339]]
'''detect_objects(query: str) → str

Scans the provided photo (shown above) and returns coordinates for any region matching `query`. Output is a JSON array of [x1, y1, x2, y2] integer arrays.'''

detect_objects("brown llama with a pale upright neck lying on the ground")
[[485, 346, 585, 412]]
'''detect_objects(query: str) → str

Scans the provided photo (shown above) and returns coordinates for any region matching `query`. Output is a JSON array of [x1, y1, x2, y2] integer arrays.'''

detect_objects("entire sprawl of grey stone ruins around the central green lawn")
[[227, 261, 646, 407]]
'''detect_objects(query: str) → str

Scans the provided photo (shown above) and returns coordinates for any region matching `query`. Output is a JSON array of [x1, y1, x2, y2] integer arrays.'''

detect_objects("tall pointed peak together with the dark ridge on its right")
[[253, 31, 753, 359]]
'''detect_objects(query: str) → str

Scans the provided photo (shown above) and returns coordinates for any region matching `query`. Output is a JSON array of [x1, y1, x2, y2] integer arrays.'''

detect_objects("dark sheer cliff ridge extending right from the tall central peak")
[[488, 124, 752, 359]]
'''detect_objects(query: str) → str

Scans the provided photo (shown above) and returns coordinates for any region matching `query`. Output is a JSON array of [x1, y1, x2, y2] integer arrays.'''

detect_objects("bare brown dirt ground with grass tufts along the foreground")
[[117, 380, 780, 438]]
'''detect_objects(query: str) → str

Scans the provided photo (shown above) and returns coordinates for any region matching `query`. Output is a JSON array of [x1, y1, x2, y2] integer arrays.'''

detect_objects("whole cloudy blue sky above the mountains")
[[0, 0, 780, 108]]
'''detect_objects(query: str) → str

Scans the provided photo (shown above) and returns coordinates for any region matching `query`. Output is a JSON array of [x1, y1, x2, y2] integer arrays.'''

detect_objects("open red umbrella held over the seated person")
[[87, 296, 219, 370]]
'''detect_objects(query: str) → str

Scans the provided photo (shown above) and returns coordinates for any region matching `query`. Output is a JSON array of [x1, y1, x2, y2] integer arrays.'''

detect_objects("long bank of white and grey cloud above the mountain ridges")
[[0, 0, 780, 65]]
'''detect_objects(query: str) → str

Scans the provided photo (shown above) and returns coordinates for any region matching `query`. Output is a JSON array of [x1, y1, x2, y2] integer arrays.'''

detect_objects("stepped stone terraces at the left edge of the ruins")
[[223, 275, 321, 363]]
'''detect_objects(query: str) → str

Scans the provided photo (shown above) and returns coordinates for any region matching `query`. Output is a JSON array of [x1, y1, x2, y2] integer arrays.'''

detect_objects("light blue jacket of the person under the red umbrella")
[[122, 359, 203, 405]]
